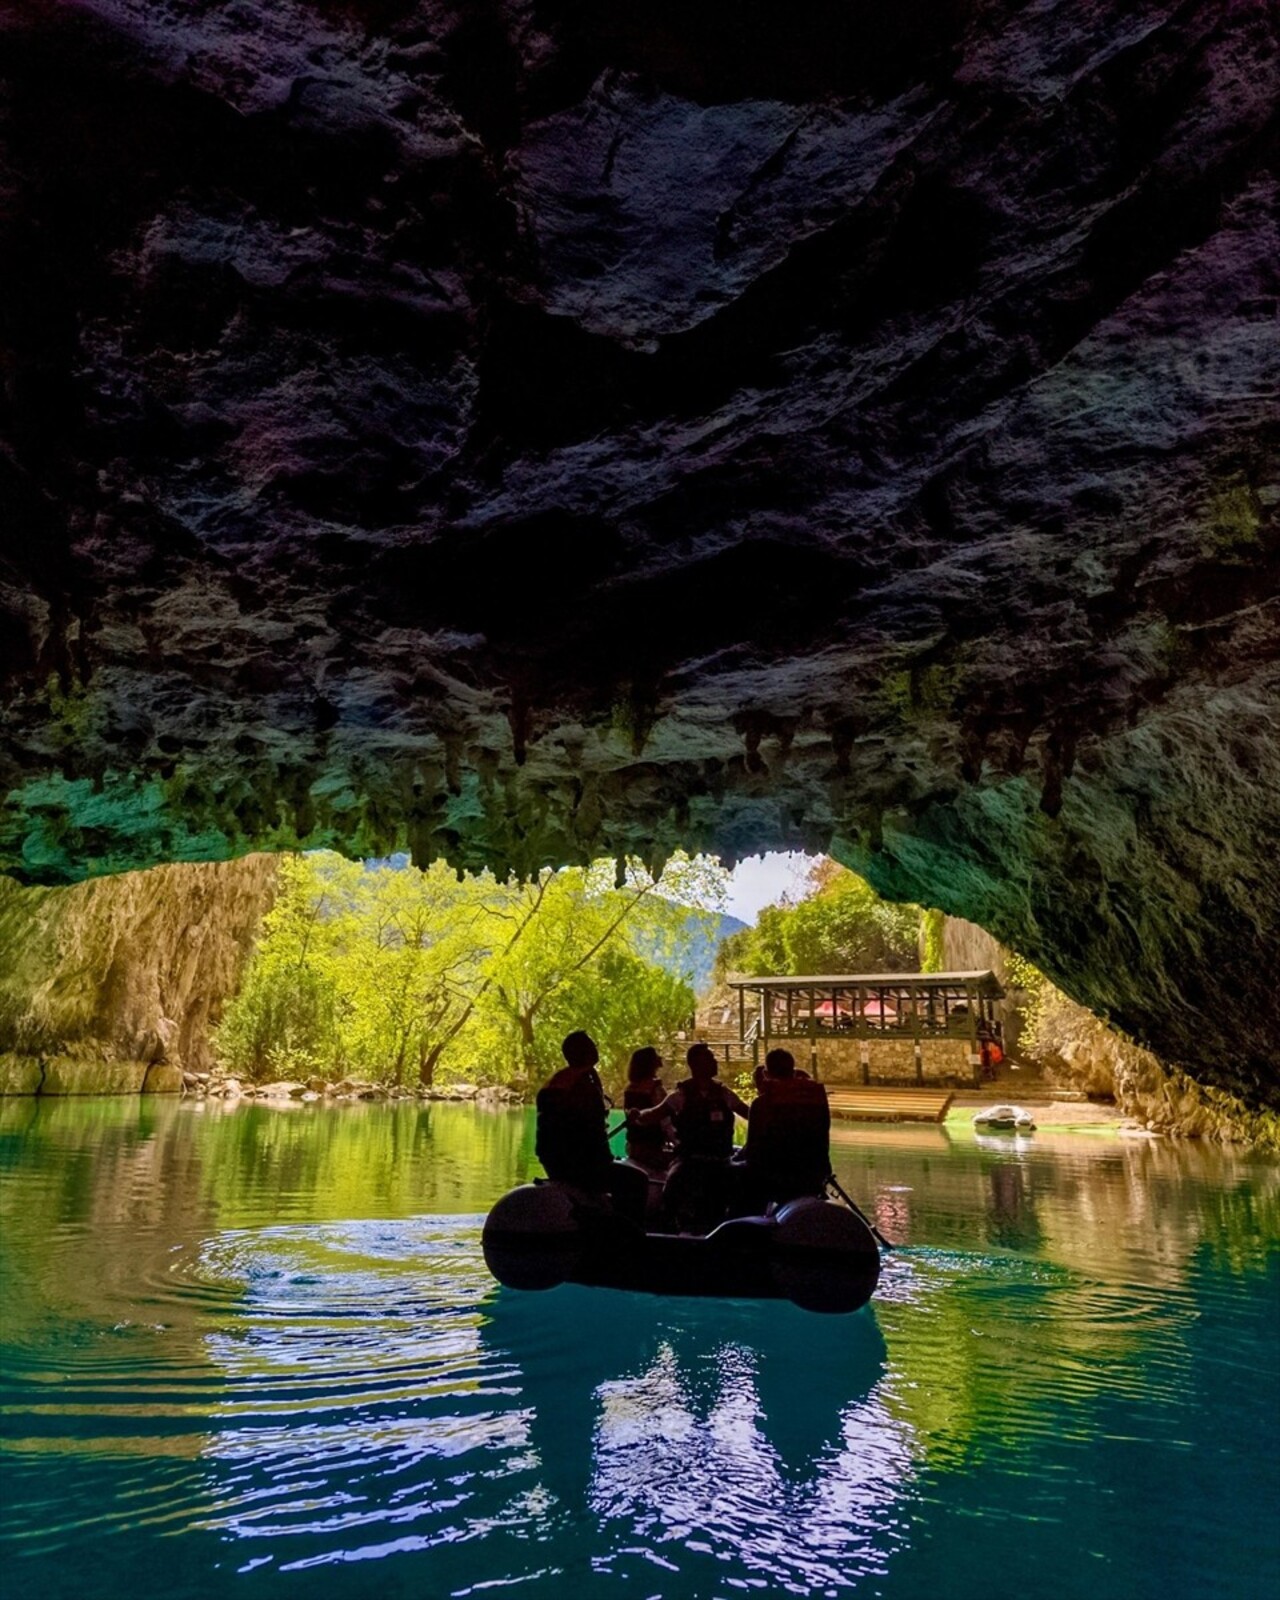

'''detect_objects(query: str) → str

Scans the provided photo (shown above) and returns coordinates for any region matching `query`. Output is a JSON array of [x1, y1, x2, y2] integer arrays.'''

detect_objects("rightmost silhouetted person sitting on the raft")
[[739, 1050, 830, 1210]]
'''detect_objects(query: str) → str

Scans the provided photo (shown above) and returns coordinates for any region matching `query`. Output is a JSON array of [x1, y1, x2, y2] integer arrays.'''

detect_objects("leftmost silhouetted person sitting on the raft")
[[534, 1030, 648, 1226]]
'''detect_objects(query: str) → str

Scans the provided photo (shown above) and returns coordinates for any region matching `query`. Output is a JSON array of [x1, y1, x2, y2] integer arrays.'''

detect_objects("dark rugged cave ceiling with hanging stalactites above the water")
[[0, 0, 1280, 1096]]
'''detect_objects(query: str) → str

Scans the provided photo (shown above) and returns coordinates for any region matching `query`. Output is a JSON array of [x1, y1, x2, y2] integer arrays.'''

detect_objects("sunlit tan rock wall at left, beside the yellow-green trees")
[[0, 854, 278, 1094]]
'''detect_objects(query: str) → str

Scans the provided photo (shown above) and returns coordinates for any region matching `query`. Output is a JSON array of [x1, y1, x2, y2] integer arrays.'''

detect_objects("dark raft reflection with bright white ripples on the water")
[[482, 1286, 914, 1594]]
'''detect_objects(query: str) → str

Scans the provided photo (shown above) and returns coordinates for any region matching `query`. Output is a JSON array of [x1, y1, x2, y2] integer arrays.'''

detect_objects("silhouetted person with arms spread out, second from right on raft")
[[629, 1045, 747, 1232]]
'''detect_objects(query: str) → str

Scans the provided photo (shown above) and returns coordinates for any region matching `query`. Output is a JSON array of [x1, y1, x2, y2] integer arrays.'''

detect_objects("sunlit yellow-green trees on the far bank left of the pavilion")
[[216, 853, 725, 1085]]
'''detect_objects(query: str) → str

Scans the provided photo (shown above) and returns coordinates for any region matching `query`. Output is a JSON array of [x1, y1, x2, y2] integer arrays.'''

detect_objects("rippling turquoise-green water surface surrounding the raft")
[[0, 1099, 1280, 1600]]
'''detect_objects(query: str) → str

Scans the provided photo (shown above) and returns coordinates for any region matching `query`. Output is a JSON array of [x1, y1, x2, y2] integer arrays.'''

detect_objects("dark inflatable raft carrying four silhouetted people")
[[483, 1181, 880, 1312]]
